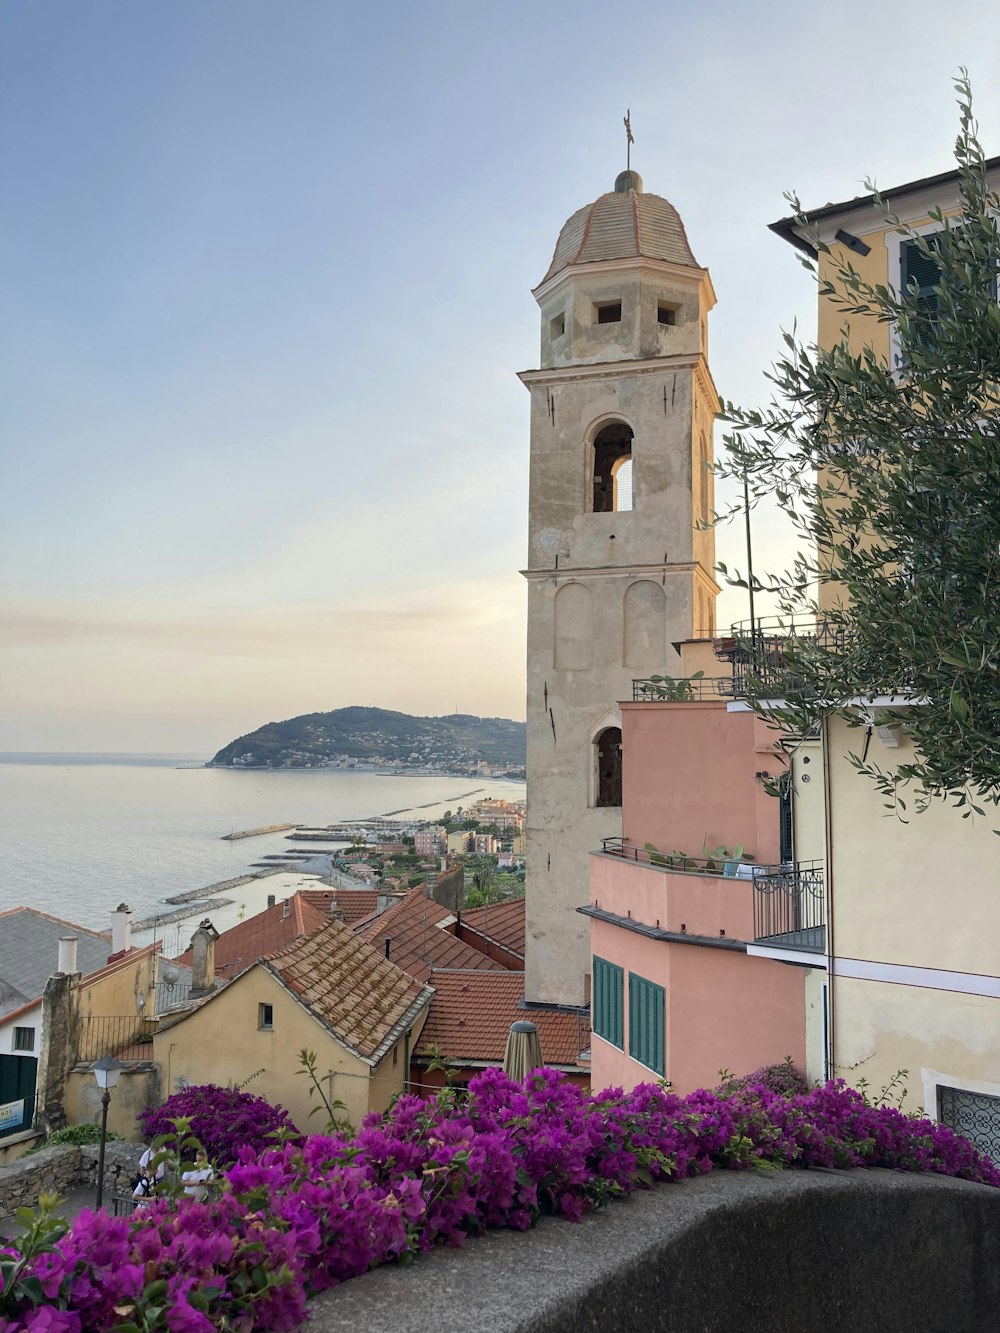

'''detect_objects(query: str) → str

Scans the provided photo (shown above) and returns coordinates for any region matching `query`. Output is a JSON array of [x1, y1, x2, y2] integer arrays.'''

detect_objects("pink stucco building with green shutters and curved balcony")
[[581, 682, 805, 1093]]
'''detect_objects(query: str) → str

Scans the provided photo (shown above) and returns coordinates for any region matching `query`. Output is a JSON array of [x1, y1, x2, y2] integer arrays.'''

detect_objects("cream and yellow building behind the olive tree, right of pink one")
[[773, 159, 1000, 1161]]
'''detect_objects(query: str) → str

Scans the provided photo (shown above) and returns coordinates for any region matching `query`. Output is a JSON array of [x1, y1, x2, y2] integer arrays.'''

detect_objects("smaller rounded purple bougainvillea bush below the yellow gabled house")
[[139, 1084, 295, 1166]]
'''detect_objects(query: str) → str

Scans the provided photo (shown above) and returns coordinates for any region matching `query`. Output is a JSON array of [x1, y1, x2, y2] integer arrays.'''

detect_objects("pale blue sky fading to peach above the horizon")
[[0, 0, 1000, 750]]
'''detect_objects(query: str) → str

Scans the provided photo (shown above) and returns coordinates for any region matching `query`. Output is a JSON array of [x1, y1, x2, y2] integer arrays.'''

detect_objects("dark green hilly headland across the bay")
[[208, 708, 524, 777]]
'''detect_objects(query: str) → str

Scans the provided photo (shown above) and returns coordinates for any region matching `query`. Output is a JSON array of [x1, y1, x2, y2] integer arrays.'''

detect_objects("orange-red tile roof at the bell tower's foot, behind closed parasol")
[[413, 972, 589, 1068]]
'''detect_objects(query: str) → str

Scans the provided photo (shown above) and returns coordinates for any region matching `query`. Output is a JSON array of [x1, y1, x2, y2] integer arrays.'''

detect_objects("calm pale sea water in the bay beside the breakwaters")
[[0, 754, 524, 952]]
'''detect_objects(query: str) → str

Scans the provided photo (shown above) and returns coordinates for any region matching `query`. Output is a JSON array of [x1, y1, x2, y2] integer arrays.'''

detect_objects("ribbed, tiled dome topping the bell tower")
[[539, 171, 700, 285]]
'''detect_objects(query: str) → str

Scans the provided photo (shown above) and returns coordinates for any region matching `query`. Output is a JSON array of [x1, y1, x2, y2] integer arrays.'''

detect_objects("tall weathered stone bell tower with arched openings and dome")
[[520, 171, 719, 1005]]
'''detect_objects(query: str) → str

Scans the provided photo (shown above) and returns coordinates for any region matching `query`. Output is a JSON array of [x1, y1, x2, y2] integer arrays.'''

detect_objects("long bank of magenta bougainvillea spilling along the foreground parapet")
[[0, 1069, 1000, 1333]]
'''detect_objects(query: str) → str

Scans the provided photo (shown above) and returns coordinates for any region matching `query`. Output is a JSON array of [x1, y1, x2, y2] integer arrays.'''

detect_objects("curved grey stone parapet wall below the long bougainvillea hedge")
[[309, 1170, 1000, 1333]]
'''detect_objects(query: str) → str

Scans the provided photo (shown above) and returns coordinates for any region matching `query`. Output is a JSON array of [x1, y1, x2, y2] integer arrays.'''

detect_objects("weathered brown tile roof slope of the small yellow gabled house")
[[261, 921, 432, 1061]]
